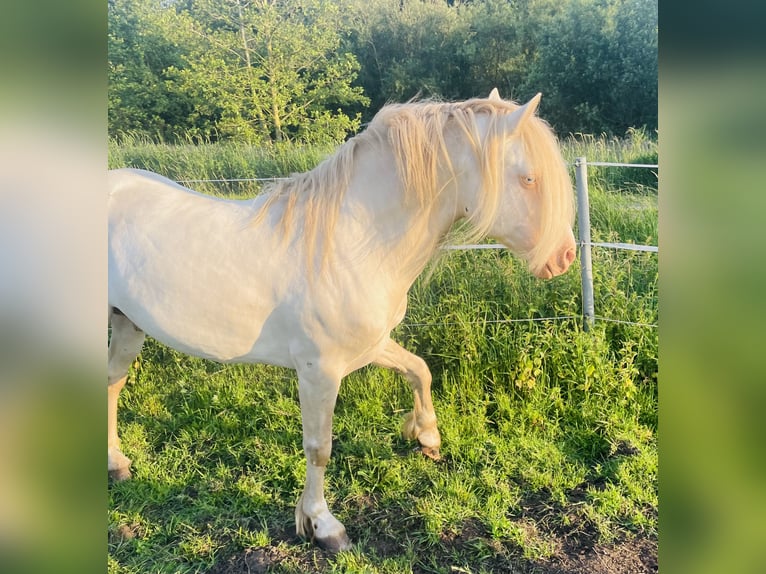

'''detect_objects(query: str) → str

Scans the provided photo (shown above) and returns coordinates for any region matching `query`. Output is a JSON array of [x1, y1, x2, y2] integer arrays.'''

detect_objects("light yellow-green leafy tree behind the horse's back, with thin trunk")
[[168, 0, 369, 142]]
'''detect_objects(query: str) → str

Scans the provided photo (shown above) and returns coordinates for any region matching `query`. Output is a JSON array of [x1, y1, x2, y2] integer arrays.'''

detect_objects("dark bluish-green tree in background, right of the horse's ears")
[[526, 0, 658, 134]]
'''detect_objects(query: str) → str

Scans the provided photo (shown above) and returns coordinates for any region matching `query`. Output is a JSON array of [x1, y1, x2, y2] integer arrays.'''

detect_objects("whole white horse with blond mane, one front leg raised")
[[108, 90, 575, 551]]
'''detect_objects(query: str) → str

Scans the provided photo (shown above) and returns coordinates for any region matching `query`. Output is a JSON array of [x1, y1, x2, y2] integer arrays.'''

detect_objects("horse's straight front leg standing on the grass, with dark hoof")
[[295, 361, 351, 552]]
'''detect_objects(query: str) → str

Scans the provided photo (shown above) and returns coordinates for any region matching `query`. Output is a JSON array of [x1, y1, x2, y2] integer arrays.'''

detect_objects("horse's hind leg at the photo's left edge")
[[107, 309, 145, 480]]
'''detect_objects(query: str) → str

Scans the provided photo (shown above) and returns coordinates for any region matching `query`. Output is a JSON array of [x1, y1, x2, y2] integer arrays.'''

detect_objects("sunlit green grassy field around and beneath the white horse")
[[108, 132, 658, 574]]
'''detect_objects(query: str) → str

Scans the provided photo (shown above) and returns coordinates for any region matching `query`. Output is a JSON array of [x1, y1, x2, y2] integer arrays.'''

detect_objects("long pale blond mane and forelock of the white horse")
[[255, 98, 574, 276]]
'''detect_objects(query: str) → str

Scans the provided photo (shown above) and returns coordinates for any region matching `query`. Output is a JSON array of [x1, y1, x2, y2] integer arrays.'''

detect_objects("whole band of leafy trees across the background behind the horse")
[[109, 0, 658, 143]]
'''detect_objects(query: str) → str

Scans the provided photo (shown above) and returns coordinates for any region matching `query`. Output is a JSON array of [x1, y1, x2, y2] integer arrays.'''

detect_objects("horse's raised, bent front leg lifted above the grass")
[[374, 339, 441, 460]]
